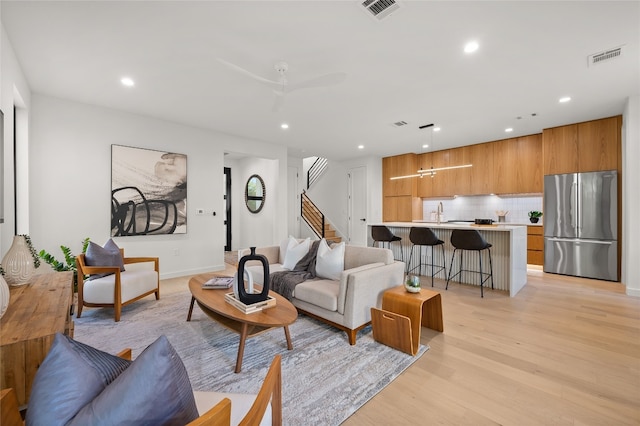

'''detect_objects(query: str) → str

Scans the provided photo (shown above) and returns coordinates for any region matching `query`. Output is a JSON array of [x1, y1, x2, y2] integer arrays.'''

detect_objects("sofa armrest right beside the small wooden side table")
[[338, 262, 405, 329]]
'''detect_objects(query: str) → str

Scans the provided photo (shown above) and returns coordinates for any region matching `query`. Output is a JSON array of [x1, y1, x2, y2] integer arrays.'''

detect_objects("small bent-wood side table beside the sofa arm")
[[371, 285, 444, 355]]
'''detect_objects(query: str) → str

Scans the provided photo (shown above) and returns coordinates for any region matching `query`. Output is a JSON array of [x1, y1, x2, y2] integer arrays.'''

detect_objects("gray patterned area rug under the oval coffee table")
[[74, 290, 428, 425]]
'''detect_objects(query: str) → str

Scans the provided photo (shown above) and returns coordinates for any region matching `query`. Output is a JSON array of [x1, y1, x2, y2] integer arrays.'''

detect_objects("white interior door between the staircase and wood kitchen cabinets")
[[349, 166, 367, 246]]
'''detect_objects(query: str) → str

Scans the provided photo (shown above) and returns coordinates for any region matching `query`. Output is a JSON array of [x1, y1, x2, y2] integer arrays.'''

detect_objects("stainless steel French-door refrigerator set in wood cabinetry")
[[542, 170, 618, 281]]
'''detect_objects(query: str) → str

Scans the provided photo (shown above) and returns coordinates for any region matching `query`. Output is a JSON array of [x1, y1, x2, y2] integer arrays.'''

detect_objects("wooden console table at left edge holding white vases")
[[0, 272, 73, 408]]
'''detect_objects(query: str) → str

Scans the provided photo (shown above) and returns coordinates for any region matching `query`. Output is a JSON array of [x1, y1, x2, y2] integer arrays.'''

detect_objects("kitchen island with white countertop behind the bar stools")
[[368, 221, 527, 297]]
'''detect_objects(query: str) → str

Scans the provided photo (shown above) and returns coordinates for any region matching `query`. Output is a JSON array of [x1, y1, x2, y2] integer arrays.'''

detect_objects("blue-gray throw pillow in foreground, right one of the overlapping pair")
[[69, 336, 198, 426]]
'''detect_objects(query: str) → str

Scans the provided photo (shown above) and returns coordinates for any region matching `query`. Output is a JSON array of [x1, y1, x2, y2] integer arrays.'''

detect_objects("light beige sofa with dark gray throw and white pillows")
[[238, 241, 405, 345]]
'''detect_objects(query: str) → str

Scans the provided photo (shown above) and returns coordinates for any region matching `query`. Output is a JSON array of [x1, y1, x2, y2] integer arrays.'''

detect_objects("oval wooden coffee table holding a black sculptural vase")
[[187, 273, 298, 373]]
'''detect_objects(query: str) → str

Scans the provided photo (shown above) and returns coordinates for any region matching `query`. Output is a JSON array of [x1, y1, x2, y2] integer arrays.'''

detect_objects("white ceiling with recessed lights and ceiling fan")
[[0, 0, 640, 160]]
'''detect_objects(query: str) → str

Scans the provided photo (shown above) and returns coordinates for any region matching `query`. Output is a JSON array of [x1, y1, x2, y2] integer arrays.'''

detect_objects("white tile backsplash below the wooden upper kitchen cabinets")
[[422, 195, 543, 224]]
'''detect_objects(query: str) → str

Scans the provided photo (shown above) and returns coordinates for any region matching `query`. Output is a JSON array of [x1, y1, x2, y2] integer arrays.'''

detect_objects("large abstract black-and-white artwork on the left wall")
[[111, 145, 187, 237]]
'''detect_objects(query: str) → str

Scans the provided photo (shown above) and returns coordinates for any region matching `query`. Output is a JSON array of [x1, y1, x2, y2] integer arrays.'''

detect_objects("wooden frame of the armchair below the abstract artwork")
[[76, 249, 160, 322]]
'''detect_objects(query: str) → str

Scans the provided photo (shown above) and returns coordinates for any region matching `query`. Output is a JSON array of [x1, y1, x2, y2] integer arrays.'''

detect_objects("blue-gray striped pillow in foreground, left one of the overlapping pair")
[[26, 333, 131, 426]]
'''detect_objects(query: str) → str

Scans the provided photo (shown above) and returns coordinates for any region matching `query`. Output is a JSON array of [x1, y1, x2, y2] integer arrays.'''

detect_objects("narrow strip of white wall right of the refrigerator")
[[622, 95, 640, 297]]
